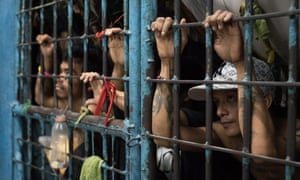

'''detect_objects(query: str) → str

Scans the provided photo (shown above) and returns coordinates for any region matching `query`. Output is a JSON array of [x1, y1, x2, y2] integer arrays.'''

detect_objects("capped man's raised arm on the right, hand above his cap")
[[205, 10, 276, 156]]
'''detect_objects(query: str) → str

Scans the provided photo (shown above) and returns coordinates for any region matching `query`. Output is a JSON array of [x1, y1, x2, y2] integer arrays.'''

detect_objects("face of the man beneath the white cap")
[[213, 90, 241, 136]]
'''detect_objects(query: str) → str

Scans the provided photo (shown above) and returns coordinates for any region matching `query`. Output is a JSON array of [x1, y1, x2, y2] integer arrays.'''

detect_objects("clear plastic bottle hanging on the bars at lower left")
[[50, 115, 69, 169]]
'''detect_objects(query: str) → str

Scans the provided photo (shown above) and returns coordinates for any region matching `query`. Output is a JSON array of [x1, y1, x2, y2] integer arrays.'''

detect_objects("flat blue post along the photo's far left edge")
[[0, 0, 18, 179]]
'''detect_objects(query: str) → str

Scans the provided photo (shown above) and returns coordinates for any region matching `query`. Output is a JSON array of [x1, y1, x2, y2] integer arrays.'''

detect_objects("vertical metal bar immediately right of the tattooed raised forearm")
[[172, 0, 181, 179]]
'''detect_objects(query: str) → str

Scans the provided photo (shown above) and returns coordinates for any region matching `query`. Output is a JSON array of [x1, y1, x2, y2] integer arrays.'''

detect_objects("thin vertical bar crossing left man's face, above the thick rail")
[[67, 0, 73, 110]]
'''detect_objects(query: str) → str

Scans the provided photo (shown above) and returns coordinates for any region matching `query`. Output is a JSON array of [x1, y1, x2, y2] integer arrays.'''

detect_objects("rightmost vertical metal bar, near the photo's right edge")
[[285, 0, 299, 179]]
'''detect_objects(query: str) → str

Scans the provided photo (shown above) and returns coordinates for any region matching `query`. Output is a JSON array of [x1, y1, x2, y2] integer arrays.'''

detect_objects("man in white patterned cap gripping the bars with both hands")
[[151, 10, 299, 179]]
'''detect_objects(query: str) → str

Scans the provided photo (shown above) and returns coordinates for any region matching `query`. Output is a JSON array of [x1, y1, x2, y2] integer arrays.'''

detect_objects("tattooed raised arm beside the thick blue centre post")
[[151, 17, 210, 150]]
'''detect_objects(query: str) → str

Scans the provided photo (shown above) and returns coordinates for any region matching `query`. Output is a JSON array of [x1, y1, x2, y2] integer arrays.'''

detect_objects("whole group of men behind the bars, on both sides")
[[35, 0, 300, 179]]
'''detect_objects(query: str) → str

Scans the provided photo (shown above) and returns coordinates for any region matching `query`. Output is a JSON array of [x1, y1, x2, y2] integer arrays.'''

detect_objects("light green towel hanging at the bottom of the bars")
[[80, 155, 103, 180]]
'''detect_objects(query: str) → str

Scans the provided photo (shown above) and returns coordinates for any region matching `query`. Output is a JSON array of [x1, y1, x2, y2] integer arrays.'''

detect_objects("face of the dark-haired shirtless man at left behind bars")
[[55, 62, 82, 99]]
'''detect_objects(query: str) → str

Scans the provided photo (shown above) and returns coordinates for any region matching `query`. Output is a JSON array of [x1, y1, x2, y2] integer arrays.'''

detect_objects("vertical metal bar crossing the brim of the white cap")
[[205, 0, 213, 180]]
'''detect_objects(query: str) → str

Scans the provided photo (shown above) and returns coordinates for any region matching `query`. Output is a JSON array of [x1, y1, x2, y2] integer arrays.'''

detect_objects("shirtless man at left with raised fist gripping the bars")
[[35, 34, 83, 112]]
